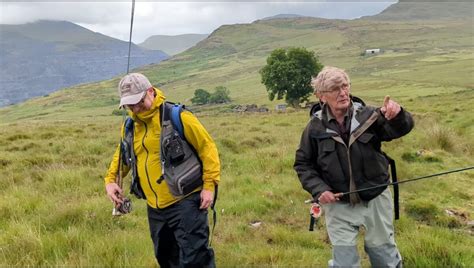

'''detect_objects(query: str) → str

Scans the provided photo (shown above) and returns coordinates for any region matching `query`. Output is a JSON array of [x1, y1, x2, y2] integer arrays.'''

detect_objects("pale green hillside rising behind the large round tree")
[[0, 0, 474, 121]]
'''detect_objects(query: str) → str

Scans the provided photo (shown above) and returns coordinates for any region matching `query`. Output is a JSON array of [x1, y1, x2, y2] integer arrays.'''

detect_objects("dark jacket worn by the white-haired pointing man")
[[294, 99, 414, 201]]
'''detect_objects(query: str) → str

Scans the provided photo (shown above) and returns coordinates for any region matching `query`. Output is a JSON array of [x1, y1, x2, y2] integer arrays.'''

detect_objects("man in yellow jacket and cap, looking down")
[[104, 73, 220, 267]]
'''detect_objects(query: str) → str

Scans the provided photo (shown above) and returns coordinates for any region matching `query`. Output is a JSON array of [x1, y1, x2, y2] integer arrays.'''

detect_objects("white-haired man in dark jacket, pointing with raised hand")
[[294, 67, 413, 267]]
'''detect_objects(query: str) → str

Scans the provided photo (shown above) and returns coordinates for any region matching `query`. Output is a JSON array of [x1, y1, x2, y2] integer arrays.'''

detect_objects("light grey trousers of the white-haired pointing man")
[[322, 188, 402, 267]]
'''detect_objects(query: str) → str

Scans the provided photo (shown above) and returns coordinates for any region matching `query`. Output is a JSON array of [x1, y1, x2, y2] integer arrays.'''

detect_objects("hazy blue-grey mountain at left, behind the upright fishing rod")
[[0, 21, 168, 106]]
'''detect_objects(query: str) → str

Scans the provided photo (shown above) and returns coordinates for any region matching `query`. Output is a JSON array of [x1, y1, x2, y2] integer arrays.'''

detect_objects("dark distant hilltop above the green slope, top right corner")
[[365, 0, 474, 22]]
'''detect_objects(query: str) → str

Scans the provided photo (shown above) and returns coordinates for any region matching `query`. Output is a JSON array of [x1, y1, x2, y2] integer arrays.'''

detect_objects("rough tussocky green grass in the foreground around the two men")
[[0, 107, 474, 266]]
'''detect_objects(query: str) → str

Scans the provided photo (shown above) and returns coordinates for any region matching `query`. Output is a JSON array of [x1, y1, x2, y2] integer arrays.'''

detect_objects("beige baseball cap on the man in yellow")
[[118, 73, 153, 108]]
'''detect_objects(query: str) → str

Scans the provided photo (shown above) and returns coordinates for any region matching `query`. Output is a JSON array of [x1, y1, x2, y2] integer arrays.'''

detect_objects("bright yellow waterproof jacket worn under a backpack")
[[104, 88, 220, 208]]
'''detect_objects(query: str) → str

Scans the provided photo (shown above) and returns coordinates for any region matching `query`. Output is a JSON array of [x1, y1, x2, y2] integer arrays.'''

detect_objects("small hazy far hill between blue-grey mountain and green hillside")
[[138, 34, 208, 55]]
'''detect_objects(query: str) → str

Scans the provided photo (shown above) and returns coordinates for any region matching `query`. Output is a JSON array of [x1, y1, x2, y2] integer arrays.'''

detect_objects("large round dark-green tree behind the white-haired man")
[[260, 47, 323, 107]]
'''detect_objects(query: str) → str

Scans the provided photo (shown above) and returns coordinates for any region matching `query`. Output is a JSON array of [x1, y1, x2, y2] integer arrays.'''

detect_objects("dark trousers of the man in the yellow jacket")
[[148, 192, 215, 268]]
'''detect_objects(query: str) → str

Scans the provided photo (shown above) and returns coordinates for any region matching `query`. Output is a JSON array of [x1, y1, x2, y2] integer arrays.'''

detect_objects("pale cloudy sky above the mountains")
[[0, 0, 397, 43]]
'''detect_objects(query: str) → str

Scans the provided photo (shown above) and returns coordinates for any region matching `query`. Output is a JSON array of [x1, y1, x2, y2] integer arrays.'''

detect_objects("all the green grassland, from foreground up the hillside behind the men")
[[0, 15, 474, 267]]
